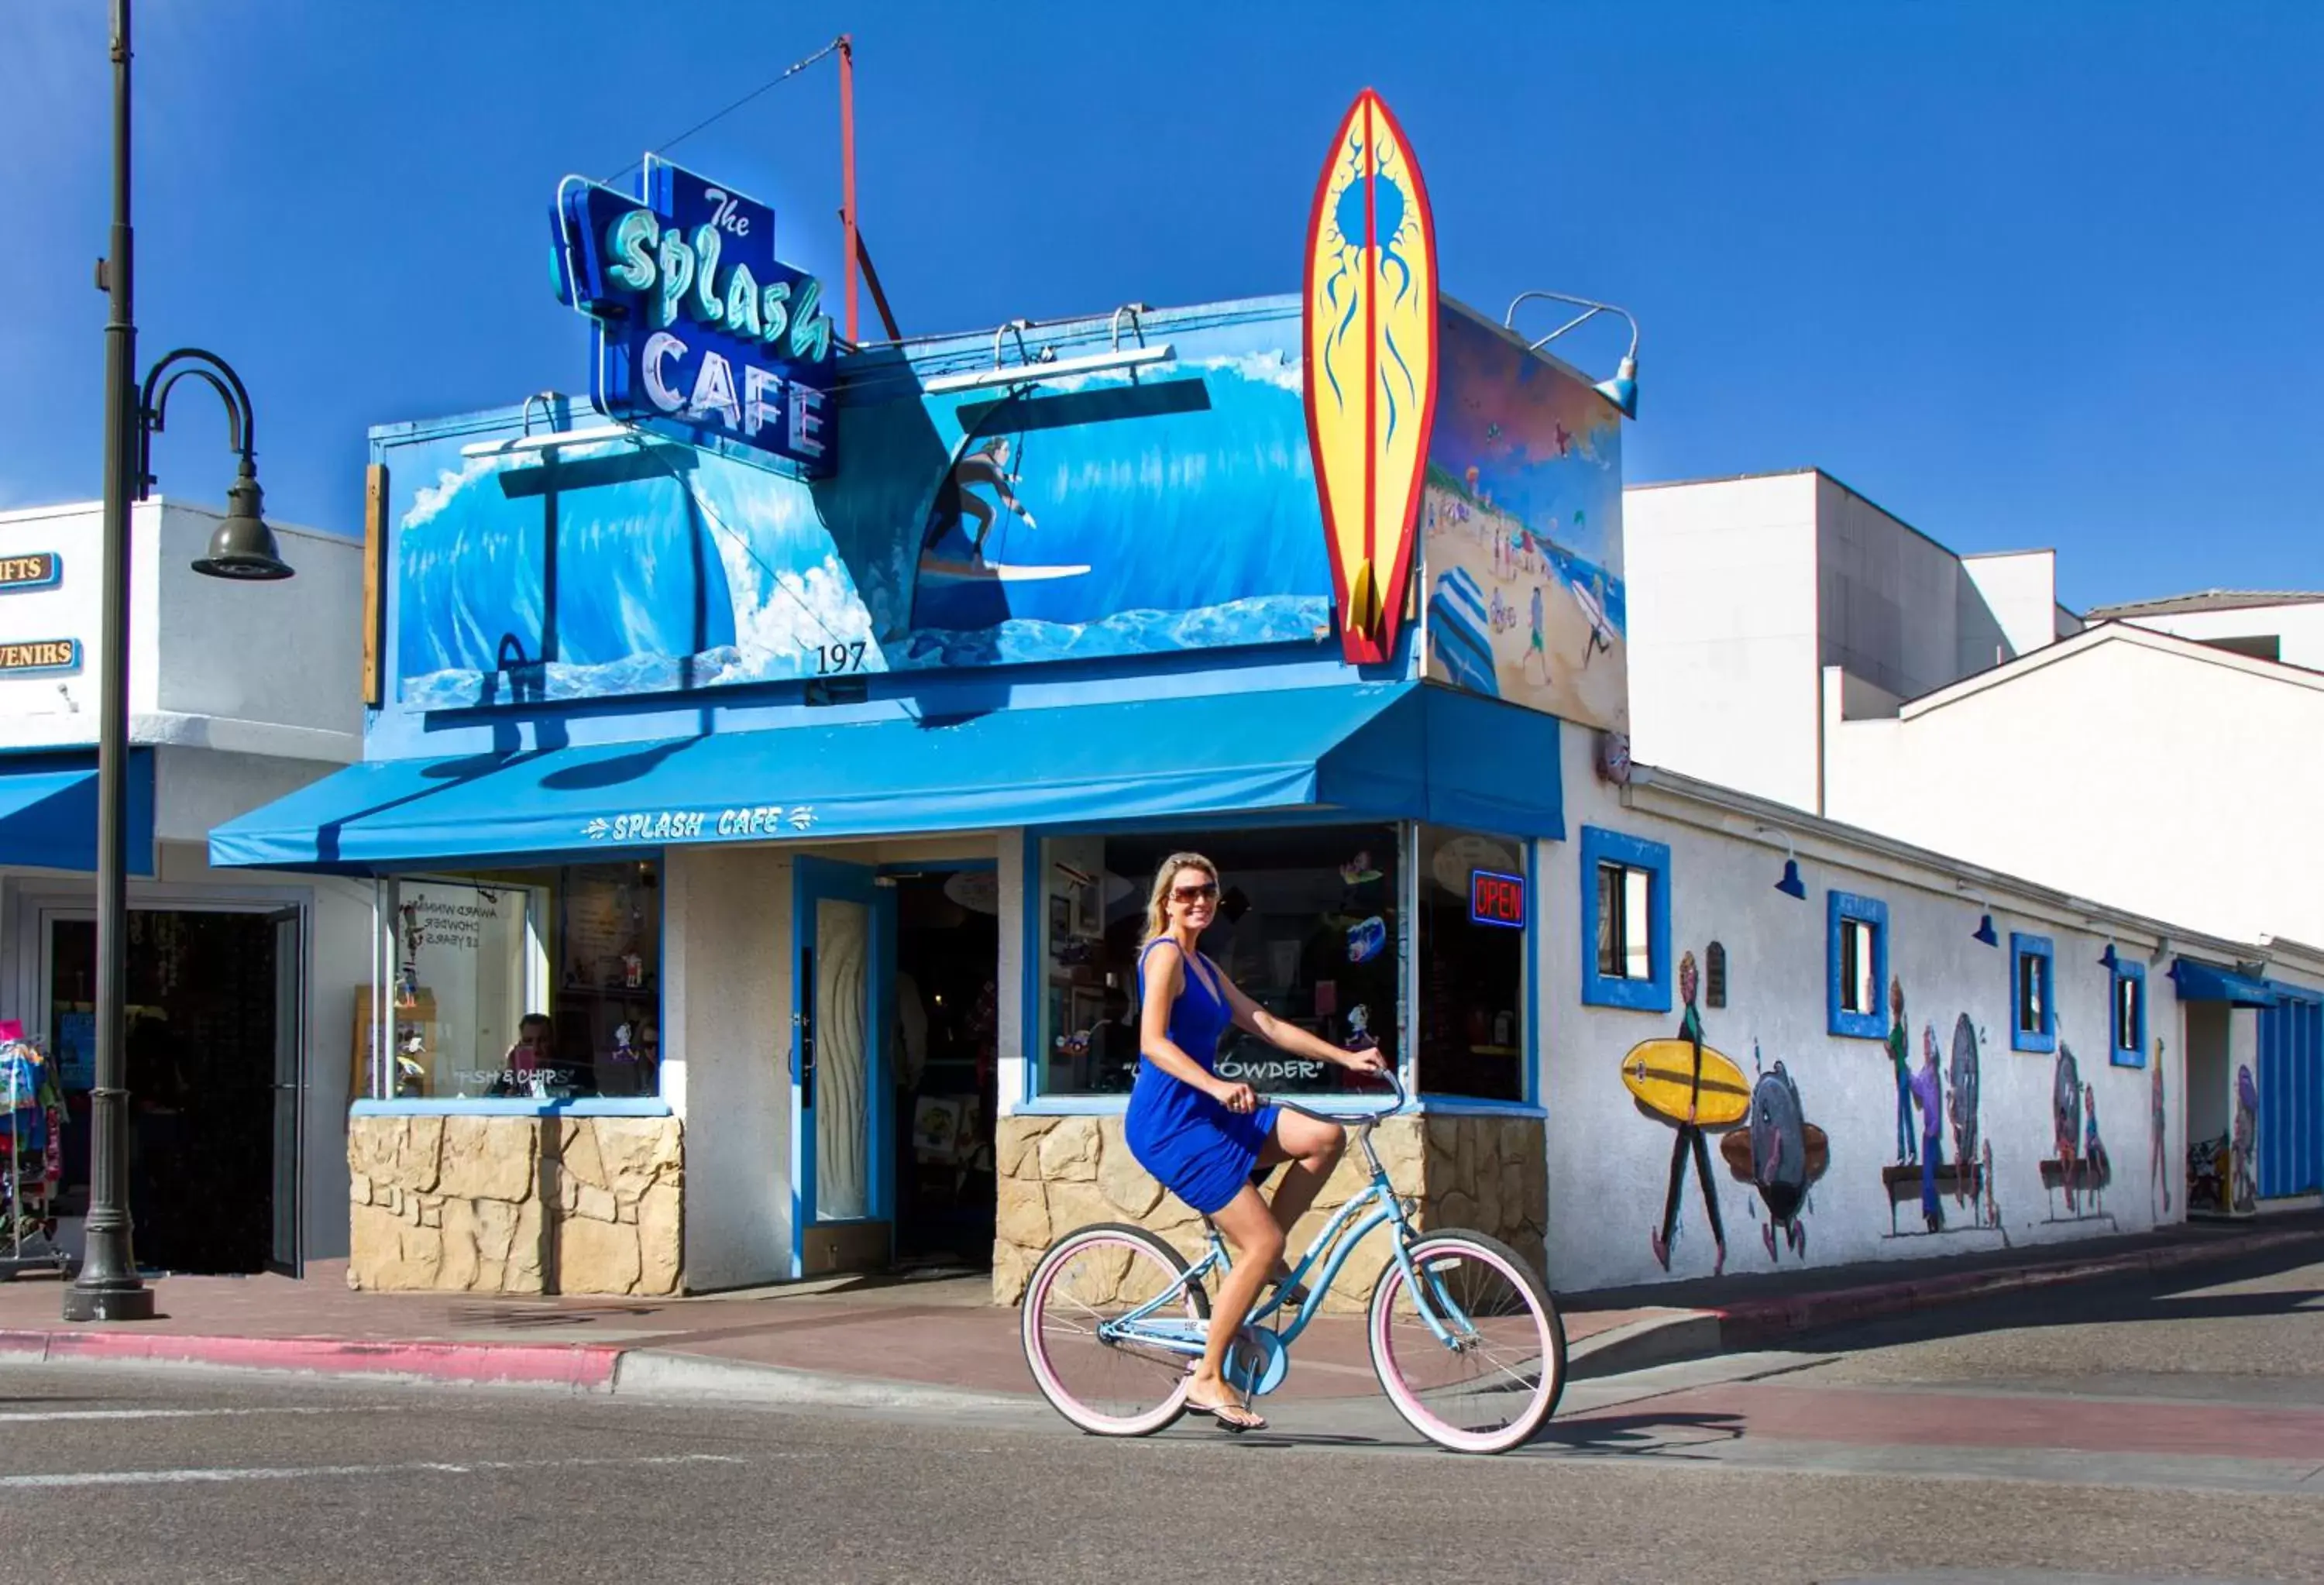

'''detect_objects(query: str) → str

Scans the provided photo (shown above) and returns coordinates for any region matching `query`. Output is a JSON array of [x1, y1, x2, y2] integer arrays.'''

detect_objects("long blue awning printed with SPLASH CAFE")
[[209, 683, 1564, 872]]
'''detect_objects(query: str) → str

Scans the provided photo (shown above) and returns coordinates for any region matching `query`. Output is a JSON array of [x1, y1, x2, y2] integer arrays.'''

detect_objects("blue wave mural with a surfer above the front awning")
[[376, 309, 1332, 709]]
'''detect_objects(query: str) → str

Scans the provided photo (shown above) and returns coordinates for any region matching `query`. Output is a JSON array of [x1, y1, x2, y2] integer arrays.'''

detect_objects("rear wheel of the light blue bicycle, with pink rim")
[[1020, 1222, 1211, 1436]]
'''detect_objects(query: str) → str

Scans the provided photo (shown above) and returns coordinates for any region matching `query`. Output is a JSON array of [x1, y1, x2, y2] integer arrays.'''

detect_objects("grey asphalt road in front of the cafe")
[[0, 1260, 2324, 1585]]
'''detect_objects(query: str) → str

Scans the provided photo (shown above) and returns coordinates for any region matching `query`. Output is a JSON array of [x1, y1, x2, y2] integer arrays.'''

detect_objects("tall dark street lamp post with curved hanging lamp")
[[65, 0, 290, 1320]]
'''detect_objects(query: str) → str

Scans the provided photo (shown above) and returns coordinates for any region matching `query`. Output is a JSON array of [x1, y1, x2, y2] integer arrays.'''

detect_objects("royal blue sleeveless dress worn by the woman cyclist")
[[1122, 939, 1276, 1215]]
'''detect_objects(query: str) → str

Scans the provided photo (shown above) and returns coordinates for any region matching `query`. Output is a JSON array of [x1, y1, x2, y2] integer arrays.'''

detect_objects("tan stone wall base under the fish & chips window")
[[346, 1118, 686, 1297]]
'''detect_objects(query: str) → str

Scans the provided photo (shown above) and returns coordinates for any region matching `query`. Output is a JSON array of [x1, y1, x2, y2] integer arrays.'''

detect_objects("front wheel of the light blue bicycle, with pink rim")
[[1371, 1232, 1566, 1453]]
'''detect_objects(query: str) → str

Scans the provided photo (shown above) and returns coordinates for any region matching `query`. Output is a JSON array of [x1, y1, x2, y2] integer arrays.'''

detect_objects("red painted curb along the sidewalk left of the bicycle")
[[0, 1329, 623, 1390]]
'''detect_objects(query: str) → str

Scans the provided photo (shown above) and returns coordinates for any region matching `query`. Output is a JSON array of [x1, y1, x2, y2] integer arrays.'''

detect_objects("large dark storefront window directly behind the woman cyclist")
[[1034, 825, 1404, 1095]]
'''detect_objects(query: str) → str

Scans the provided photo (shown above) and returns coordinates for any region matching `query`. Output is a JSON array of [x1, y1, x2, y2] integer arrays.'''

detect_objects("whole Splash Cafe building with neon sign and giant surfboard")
[[214, 95, 2305, 1299]]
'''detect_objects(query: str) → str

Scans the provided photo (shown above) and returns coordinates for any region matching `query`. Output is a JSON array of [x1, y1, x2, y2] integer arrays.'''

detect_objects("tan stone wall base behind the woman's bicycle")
[[992, 1116, 1548, 1313]]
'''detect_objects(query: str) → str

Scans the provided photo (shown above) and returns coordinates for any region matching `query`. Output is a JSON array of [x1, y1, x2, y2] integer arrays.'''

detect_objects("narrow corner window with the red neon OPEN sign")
[[1415, 825, 1532, 1102]]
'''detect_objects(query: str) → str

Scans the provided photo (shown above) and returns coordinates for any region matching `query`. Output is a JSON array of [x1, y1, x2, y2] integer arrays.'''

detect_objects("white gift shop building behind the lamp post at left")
[[0, 500, 372, 1271]]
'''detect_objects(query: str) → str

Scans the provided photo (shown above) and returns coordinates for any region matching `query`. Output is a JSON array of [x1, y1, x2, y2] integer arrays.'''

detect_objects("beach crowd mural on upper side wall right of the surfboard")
[[1420, 302, 1629, 732]]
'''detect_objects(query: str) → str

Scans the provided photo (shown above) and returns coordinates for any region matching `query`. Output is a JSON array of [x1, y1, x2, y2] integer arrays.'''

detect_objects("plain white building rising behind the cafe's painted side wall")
[[1624, 472, 2324, 1195]]
